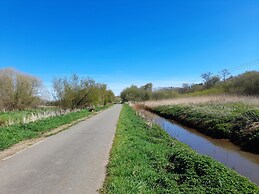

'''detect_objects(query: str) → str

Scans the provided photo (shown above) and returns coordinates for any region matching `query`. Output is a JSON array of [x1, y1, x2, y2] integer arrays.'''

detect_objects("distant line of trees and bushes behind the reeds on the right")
[[120, 69, 259, 102]]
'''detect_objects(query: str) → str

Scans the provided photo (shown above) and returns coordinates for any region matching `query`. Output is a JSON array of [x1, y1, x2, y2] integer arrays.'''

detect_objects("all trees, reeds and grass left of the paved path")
[[0, 68, 116, 151]]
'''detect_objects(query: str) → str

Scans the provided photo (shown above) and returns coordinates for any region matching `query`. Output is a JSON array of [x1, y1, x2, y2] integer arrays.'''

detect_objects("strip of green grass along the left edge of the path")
[[0, 106, 108, 151]]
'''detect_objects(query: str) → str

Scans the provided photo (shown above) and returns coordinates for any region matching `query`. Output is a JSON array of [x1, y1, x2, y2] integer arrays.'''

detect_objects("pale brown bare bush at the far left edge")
[[0, 68, 42, 110]]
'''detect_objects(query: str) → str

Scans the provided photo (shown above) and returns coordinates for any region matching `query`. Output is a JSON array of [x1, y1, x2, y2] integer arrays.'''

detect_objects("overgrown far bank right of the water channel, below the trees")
[[152, 103, 259, 153]]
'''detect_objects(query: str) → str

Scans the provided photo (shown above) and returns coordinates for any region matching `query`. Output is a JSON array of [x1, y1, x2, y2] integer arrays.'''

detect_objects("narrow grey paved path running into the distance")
[[0, 105, 121, 194]]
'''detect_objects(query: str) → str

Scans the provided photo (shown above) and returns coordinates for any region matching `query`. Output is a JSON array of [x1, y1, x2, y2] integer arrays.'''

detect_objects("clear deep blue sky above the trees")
[[0, 0, 259, 94]]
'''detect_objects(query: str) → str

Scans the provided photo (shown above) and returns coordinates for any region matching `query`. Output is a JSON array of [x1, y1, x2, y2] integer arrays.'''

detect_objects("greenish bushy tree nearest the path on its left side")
[[53, 74, 115, 109]]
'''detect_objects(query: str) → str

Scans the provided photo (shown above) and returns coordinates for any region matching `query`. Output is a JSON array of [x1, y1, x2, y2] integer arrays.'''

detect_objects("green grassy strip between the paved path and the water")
[[102, 106, 259, 194]]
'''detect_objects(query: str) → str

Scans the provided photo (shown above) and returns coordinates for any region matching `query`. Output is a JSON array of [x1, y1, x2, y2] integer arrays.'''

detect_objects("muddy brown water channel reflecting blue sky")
[[139, 110, 259, 185]]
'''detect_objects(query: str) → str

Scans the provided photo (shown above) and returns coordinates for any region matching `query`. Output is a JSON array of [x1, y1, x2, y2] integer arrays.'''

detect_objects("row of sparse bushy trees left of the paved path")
[[0, 68, 115, 110]]
